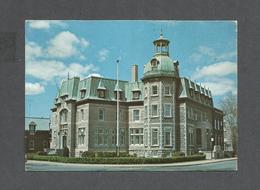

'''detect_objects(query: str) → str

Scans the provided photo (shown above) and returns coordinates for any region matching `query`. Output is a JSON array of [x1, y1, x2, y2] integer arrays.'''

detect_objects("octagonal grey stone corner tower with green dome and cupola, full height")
[[142, 33, 179, 157]]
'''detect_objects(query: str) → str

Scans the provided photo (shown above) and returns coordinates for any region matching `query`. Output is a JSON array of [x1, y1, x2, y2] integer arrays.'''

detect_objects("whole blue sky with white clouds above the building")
[[25, 20, 237, 117]]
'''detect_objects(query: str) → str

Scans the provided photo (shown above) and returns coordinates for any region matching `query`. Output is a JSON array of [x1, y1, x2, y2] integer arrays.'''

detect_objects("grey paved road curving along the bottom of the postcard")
[[25, 160, 237, 171]]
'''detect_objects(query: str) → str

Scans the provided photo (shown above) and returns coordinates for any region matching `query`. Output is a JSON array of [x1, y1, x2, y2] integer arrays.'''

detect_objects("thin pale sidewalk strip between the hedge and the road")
[[26, 158, 237, 167]]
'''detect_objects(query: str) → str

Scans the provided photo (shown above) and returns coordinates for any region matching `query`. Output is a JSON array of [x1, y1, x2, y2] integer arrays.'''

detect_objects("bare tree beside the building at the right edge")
[[220, 93, 238, 155]]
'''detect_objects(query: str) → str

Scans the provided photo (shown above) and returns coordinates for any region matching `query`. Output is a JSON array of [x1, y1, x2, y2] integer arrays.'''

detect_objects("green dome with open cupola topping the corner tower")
[[143, 33, 179, 79]]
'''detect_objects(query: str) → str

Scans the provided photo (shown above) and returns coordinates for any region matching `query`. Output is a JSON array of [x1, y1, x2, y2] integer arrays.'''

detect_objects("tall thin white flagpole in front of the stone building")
[[116, 60, 119, 156]]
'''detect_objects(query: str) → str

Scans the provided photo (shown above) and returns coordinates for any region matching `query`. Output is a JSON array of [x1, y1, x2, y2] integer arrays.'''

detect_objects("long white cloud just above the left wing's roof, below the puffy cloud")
[[26, 60, 98, 81]]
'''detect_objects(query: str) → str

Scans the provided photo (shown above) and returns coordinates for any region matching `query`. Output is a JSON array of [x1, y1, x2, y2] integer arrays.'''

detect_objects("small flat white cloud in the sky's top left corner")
[[26, 20, 66, 29]]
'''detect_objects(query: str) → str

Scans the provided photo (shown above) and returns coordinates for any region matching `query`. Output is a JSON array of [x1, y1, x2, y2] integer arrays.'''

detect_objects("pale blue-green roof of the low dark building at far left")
[[25, 117, 50, 131]]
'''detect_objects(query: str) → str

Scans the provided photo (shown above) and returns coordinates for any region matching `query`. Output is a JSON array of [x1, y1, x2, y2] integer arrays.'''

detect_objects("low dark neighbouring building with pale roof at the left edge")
[[24, 117, 51, 153]]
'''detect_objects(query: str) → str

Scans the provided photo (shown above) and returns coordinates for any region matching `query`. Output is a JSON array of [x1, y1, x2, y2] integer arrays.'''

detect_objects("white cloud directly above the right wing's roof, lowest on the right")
[[201, 78, 237, 96]]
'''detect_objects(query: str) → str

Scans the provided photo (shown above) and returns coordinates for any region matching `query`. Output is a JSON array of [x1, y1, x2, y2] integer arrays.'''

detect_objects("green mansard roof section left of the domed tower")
[[54, 76, 143, 104]]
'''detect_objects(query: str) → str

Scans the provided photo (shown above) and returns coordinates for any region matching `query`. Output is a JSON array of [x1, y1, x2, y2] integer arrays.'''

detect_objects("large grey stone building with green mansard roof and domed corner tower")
[[51, 34, 224, 157]]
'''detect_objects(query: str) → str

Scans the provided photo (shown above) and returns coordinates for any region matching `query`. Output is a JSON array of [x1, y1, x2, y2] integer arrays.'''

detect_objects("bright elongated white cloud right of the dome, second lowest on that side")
[[192, 61, 237, 79]]
